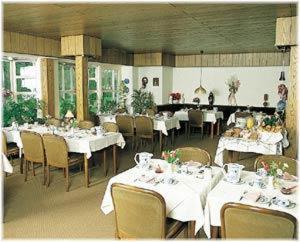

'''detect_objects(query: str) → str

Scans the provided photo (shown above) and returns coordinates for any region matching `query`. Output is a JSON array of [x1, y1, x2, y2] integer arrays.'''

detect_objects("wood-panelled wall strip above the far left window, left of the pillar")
[[3, 31, 60, 57]]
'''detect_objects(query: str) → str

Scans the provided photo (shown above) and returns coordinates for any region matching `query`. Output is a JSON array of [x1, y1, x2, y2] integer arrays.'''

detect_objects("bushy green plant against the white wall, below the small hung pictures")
[[131, 89, 155, 113]]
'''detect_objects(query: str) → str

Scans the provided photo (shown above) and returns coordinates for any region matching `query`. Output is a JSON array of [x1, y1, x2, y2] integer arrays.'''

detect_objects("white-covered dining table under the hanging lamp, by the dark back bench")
[[174, 109, 224, 139]]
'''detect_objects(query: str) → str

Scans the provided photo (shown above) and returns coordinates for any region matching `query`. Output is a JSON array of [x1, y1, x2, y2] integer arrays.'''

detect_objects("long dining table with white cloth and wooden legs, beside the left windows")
[[3, 125, 125, 187]]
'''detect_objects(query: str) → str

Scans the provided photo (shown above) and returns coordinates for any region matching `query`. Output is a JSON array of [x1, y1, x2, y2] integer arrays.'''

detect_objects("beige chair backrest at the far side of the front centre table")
[[176, 147, 211, 166]]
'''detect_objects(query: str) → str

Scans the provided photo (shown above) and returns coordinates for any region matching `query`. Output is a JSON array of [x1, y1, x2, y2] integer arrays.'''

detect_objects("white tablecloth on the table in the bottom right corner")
[[204, 171, 299, 238]]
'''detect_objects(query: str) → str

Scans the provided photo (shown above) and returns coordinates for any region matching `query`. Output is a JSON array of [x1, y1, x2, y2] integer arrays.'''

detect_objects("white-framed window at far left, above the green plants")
[[2, 58, 40, 99]]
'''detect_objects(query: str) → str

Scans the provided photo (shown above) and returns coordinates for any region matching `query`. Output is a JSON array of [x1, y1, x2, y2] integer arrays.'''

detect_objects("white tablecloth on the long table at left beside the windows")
[[3, 126, 125, 158]]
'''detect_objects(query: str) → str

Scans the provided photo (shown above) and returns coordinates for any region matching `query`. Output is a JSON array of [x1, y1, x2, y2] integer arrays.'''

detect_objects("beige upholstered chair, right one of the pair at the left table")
[[43, 134, 84, 192]]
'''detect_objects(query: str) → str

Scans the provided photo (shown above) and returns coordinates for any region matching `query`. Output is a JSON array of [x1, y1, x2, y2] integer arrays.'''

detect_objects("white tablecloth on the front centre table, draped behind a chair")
[[101, 162, 222, 234]]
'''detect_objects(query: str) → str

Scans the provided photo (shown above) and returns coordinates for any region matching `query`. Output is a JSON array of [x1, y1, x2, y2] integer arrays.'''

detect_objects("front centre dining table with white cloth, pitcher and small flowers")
[[101, 159, 222, 238]]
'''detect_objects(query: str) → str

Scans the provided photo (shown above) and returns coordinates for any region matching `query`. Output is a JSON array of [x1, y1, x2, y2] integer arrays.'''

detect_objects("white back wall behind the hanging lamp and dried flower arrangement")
[[172, 66, 289, 107]]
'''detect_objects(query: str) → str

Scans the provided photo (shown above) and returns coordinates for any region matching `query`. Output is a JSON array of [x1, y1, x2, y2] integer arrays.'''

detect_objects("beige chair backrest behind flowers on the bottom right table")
[[254, 155, 297, 176]]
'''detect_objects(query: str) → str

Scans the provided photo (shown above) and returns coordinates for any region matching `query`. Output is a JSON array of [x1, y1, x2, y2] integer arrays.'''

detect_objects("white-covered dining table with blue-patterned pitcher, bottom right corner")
[[204, 171, 299, 238]]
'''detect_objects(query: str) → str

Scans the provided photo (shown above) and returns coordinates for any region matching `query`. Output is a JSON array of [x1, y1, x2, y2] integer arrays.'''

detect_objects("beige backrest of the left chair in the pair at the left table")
[[21, 131, 45, 163]]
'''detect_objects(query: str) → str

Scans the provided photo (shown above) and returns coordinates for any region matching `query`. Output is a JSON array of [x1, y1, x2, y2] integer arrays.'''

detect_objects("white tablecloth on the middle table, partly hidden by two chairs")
[[99, 115, 180, 135]]
